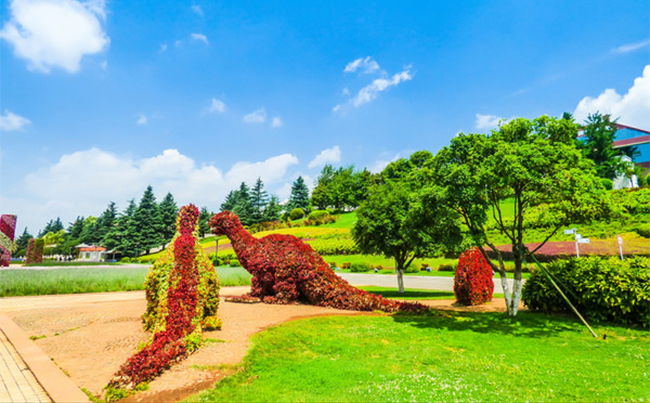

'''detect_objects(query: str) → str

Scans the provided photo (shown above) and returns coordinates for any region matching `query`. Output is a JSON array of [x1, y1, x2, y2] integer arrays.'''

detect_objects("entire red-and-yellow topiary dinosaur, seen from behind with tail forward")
[[107, 204, 221, 389]]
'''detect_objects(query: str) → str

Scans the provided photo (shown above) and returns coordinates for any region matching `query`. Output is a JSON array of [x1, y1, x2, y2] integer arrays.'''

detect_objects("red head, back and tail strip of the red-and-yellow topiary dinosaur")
[[108, 204, 210, 389]]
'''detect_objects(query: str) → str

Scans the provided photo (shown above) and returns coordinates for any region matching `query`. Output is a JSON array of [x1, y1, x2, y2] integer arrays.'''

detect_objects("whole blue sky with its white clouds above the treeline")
[[0, 0, 650, 233]]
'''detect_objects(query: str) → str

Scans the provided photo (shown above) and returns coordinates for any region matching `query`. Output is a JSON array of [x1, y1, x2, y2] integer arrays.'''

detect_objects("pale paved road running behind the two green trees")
[[336, 273, 526, 293]]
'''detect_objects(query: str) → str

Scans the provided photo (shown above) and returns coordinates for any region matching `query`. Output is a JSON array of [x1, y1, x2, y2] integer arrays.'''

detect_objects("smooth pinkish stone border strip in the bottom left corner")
[[0, 312, 90, 403]]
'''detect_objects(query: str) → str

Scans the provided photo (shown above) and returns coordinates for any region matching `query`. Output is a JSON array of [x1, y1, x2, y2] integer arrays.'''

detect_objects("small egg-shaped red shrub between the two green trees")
[[454, 248, 494, 305]]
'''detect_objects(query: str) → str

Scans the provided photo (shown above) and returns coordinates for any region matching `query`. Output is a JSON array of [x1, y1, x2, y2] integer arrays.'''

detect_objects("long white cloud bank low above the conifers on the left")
[[12, 148, 298, 233]]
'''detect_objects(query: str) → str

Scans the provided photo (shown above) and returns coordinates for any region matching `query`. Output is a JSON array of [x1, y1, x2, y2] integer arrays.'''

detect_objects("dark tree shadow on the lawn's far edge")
[[392, 311, 591, 338]]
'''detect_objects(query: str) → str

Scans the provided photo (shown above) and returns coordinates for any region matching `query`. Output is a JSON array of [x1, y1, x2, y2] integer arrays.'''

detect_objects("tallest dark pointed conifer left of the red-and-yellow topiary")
[[133, 186, 163, 253]]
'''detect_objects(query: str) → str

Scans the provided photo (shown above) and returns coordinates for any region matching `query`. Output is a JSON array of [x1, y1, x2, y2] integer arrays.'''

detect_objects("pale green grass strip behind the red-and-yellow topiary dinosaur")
[[0, 267, 251, 297]]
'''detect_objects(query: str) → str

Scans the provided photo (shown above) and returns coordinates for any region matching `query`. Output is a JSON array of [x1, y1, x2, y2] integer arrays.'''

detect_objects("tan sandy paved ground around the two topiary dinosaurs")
[[7, 287, 516, 402]]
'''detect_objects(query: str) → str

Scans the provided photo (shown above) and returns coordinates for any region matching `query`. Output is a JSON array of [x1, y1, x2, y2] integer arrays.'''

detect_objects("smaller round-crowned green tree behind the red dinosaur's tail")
[[352, 174, 460, 293]]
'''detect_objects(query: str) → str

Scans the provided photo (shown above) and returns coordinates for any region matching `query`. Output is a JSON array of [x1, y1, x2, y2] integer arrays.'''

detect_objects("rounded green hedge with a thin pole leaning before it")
[[522, 256, 650, 327]]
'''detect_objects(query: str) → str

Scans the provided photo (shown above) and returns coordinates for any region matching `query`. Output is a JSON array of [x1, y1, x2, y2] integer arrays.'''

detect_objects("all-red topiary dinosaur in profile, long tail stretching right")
[[210, 211, 428, 312]]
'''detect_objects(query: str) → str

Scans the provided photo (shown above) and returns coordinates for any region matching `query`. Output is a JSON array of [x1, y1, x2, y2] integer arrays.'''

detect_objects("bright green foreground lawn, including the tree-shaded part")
[[187, 312, 650, 402]]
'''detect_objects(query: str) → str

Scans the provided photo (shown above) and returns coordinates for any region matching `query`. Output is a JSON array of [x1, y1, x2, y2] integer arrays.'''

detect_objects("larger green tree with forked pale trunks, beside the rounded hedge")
[[426, 116, 611, 316]]
